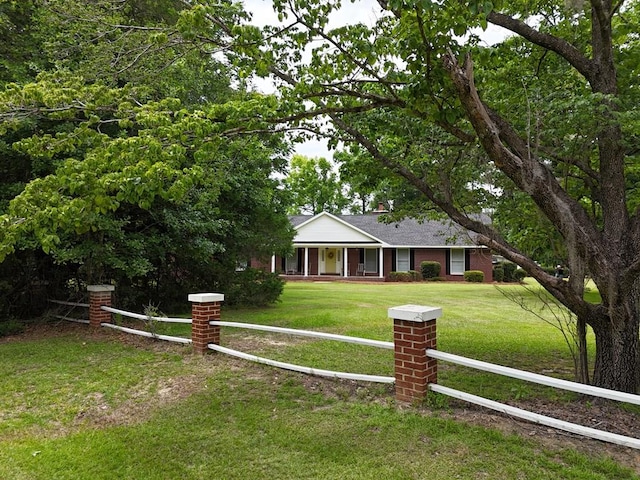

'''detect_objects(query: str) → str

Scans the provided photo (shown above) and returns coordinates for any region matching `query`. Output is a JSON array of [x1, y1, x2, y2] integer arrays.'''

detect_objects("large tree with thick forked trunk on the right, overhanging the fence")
[[179, 0, 640, 392]]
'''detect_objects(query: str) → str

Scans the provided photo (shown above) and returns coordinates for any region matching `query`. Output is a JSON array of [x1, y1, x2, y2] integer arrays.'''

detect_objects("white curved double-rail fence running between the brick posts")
[[52, 301, 640, 449]]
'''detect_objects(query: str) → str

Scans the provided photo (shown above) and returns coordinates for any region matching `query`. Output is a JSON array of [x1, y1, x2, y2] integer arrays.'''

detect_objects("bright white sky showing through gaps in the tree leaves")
[[243, 0, 506, 160]]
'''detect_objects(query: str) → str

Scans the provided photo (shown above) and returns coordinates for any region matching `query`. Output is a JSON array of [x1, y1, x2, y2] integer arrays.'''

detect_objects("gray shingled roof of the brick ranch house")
[[289, 214, 477, 247]]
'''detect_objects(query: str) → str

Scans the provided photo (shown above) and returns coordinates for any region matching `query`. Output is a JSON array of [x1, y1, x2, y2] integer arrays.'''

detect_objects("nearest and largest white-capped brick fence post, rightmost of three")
[[389, 305, 442, 403]]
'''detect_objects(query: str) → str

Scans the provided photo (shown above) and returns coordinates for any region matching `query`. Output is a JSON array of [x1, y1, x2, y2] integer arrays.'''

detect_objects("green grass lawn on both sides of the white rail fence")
[[0, 283, 638, 480]]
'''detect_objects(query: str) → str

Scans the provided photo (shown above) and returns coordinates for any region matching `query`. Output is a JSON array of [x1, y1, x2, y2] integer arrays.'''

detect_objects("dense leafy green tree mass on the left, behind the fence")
[[0, 0, 291, 313]]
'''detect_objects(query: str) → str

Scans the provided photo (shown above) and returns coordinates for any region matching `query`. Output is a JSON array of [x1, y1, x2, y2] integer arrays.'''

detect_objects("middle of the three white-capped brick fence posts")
[[189, 293, 224, 355]]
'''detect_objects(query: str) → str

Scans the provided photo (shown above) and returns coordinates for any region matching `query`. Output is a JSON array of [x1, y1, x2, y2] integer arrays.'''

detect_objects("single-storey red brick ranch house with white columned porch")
[[252, 212, 493, 282]]
